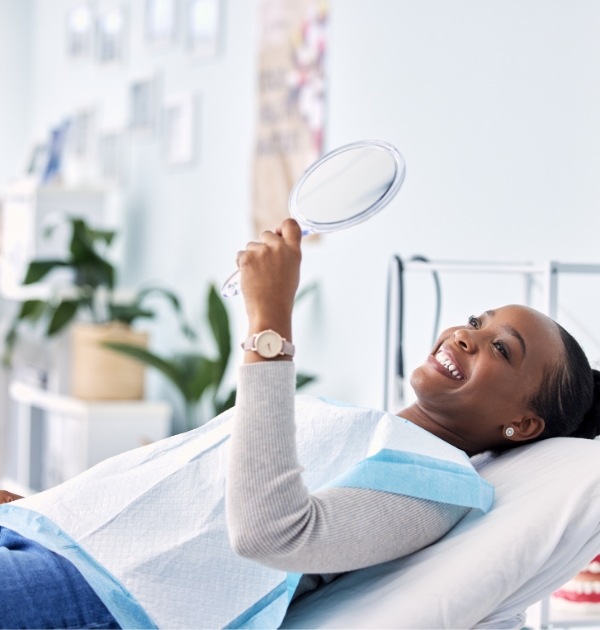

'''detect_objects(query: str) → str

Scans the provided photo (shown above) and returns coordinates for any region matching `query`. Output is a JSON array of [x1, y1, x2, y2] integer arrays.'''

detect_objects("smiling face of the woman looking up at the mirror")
[[403, 306, 564, 454]]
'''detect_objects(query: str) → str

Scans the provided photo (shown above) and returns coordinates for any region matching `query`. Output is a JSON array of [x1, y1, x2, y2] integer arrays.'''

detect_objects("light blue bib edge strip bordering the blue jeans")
[[0, 504, 158, 630]]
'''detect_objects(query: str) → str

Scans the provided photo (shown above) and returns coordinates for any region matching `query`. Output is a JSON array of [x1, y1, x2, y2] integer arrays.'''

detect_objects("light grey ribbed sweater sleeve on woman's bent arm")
[[226, 361, 468, 573]]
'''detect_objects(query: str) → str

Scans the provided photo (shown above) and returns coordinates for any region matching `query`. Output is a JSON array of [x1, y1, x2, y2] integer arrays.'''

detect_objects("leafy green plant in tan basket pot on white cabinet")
[[4, 217, 194, 400]]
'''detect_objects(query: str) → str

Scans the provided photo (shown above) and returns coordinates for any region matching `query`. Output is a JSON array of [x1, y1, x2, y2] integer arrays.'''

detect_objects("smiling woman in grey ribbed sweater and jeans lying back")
[[0, 220, 600, 627]]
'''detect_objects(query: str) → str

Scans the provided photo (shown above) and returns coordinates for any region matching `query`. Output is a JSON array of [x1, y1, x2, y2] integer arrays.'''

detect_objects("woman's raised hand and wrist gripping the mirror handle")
[[237, 219, 302, 360]]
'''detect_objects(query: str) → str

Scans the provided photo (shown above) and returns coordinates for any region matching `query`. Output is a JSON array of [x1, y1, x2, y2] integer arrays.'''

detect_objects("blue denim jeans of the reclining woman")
[[0, 527, 120, 628]]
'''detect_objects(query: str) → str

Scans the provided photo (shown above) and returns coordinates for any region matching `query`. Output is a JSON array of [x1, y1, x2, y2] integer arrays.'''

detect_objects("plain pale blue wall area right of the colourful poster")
[[309, 0, 600, 404]]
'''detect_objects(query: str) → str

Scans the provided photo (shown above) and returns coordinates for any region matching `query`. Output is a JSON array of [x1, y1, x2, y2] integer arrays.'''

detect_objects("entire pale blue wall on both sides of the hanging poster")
[[5, 0, 600, 424]]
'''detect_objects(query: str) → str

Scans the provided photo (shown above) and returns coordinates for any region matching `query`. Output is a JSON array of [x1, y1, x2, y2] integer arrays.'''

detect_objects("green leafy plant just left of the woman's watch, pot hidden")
[[104, 285, 316, 431]]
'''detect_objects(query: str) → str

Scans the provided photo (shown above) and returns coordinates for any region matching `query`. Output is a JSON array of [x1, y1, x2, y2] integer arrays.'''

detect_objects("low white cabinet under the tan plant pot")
[[8, 382, 172, 490]]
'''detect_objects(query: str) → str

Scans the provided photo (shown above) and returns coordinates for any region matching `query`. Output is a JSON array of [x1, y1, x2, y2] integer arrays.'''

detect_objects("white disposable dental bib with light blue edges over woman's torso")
[[0, 396, 494, 628]]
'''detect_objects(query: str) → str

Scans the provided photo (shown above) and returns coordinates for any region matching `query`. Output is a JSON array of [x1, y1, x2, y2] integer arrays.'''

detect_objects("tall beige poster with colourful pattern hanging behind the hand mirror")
[[253, 0, 329, 236]]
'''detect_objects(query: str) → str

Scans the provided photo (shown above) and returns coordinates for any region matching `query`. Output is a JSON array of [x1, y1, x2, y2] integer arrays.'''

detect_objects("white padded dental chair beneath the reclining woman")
[[281, 438, 600, 628]]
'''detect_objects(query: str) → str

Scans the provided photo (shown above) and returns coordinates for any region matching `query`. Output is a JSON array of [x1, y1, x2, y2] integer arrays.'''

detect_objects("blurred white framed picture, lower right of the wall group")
[[162, 92, 196, 165]]
